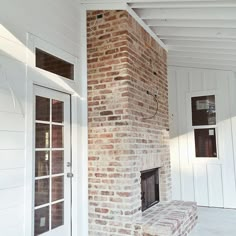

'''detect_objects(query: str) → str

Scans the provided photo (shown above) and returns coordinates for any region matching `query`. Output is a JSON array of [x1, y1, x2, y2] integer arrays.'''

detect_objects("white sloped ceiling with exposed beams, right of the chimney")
[[128, 0, 236, 71]]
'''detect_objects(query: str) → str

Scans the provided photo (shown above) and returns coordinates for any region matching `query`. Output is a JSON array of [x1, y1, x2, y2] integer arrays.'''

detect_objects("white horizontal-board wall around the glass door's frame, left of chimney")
[[0, 0, 79, 236]]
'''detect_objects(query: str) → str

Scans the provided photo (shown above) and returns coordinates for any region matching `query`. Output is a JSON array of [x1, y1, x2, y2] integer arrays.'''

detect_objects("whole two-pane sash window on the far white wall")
[[191, 95, 217, 158]]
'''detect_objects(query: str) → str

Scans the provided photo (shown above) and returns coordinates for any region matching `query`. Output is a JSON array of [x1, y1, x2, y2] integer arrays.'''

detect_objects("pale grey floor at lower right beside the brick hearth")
[[189, 207, 236, 236]]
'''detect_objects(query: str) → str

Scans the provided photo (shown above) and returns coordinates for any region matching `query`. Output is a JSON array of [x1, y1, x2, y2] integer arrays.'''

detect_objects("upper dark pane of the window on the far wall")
[[192, 95, 216, 126]]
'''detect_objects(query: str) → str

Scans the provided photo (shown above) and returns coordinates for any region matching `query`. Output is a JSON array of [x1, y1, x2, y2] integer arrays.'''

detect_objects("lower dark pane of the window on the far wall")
[[194, 128, 217, 157]]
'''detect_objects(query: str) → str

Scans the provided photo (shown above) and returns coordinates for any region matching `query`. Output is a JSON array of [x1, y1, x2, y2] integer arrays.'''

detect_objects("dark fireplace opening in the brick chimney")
[[141, 169, 159, 211]]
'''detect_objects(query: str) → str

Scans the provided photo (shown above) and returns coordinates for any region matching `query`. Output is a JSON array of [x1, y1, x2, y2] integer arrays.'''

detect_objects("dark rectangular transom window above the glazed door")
[[36, 48, 74, 80]]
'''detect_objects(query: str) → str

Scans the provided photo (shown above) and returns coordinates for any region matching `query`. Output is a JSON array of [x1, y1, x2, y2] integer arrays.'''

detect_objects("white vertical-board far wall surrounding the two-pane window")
[[168, 67, 236, 208]]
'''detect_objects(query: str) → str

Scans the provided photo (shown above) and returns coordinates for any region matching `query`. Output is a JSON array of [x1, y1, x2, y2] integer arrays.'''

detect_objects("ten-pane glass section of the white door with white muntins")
[[34, 95, 66, 235]]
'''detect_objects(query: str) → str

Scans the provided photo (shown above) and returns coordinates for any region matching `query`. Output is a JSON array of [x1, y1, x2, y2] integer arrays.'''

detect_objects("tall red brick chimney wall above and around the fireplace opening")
[[88, 11, 171, 236]]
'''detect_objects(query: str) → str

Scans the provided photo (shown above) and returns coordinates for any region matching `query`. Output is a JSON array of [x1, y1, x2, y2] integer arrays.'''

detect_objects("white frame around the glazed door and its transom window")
[[24, 33, 88, 236]]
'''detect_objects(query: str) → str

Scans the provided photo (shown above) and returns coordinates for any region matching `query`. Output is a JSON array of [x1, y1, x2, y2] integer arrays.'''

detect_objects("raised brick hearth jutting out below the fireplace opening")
[[135, 201, 198, 236]]
